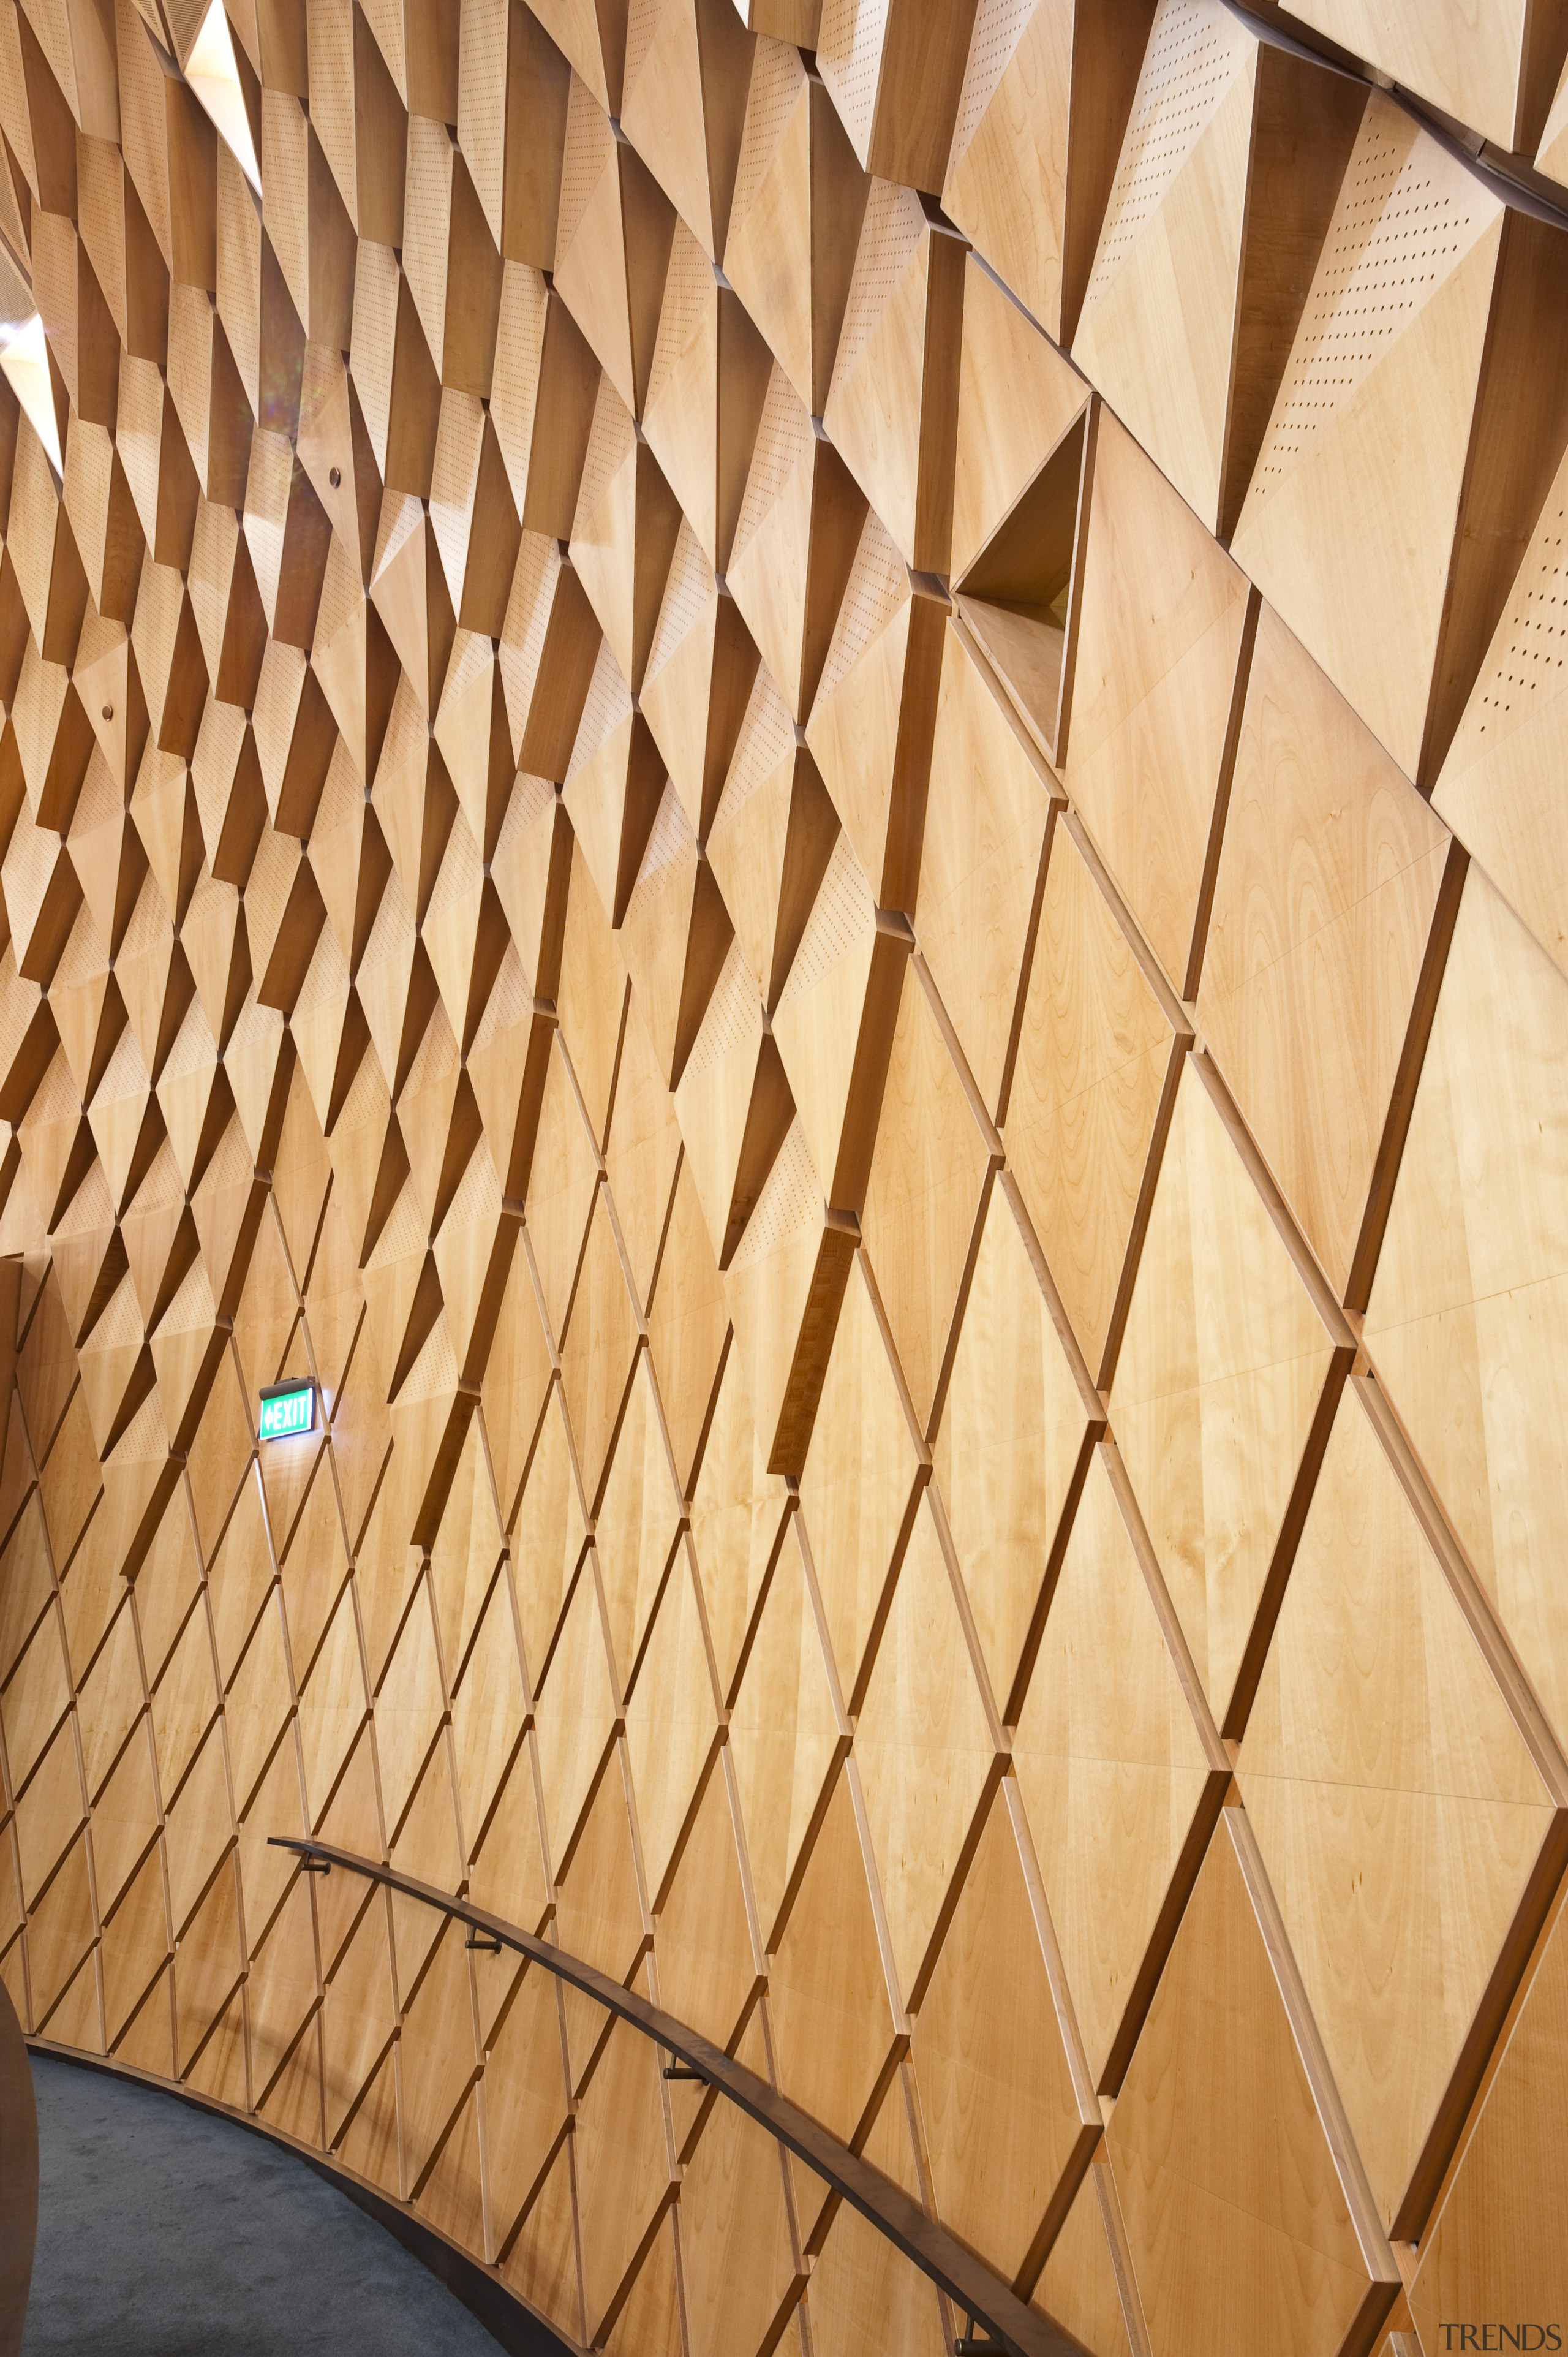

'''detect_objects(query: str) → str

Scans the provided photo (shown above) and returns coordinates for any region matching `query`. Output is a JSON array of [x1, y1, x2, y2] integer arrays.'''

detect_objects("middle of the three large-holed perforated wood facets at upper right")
[[1252, 101, 1490, 500]]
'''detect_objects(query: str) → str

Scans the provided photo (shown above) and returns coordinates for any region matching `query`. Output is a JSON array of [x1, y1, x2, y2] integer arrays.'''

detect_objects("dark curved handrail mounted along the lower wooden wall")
[[271, 1834, 1085, 2357]]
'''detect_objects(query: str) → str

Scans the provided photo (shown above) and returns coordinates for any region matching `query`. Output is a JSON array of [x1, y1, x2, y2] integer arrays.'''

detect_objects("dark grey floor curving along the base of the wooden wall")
[[21, 2056, 511, 2357]]
